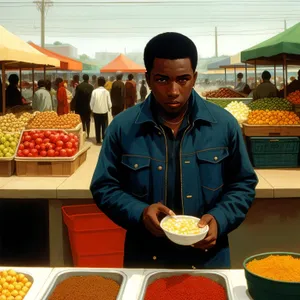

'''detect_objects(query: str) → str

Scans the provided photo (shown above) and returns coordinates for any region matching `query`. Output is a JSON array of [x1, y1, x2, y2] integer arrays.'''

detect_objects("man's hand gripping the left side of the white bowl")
[[143, 203, 175, 236]]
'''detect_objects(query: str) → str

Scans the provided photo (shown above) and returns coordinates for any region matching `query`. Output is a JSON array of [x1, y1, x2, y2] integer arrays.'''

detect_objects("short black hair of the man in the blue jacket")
[[144, 32, 198, 72]]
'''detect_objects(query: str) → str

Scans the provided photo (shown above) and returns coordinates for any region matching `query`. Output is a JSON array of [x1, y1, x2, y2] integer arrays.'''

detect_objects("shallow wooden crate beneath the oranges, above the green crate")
[[243, 123, 300, 136]]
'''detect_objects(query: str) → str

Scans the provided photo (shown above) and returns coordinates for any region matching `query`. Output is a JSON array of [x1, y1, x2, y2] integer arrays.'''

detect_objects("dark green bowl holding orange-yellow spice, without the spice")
[[243, 252, 300, 300]]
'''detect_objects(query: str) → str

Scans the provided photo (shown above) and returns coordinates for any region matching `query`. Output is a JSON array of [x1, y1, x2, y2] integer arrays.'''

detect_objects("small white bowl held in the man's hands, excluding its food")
[[160, 215, 209, 246]]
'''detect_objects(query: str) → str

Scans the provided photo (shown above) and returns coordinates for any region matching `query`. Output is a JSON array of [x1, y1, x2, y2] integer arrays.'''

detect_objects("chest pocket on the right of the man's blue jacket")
[[197, 148, 229, 192]]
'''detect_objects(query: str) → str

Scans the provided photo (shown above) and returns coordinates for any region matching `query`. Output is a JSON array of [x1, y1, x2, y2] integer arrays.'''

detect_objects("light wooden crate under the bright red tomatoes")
[[16, 144, 90, 177]]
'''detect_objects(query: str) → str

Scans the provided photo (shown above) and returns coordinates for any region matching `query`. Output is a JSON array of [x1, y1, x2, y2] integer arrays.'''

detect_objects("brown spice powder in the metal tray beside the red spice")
[[48, 275, 120, 300]]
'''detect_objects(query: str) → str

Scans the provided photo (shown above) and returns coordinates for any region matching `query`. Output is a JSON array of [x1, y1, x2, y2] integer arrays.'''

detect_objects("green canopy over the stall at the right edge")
[[241, 23, 300, 65]]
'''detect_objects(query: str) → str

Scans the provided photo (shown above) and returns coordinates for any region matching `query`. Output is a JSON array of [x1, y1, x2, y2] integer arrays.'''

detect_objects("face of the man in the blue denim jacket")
[[146, 58, 197, 114]]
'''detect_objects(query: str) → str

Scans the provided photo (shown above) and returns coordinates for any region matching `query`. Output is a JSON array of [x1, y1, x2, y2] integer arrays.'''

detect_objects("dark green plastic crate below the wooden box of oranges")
[[248, 137, 300, 168]]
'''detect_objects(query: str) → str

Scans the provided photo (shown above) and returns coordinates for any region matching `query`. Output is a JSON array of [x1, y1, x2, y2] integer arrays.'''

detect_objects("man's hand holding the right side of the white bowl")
[[192, 215, 218, 250]]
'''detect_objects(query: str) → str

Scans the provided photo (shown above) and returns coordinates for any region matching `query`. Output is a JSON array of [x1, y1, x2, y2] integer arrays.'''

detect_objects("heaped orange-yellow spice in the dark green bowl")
[[246, 255, 300, 282]]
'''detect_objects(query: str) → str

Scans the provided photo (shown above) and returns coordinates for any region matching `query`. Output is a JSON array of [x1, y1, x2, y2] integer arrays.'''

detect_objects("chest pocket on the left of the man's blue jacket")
[[122, 155, 150, 200]]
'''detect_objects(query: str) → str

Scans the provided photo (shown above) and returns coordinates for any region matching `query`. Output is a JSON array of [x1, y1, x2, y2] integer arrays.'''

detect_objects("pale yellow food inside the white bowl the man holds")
[[162, 217, 201, 235]]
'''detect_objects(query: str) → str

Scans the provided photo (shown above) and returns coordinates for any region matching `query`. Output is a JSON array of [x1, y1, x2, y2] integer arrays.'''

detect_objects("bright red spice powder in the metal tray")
[[145, 275, 227, 300]]
